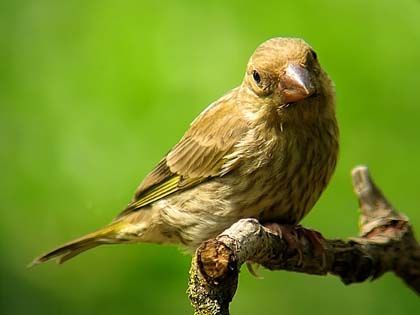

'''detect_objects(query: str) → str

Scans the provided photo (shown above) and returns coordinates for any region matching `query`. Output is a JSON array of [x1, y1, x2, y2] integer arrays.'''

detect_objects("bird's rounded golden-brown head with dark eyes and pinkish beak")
[[240, 38, 334, 121]]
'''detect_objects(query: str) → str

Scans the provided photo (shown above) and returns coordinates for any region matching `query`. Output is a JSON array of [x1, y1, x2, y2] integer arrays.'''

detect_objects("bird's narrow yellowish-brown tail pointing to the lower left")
[[28, 221, 124, 267]]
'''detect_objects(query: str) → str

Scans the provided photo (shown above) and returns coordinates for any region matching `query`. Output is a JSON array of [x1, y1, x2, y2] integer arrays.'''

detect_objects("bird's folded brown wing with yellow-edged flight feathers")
[[117, 90, 248, 218]]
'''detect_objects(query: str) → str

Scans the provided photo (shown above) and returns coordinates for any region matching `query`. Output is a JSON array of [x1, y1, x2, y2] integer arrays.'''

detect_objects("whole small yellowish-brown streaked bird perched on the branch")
[[32, 38, 338, 264]]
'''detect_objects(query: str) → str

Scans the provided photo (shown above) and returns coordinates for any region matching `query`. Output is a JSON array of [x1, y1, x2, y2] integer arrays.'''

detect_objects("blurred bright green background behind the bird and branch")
[[0, 0, 420, 315]]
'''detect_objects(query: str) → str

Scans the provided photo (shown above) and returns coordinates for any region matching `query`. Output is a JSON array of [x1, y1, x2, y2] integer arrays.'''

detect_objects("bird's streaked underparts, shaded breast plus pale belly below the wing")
[[152, 119, 337, 249]]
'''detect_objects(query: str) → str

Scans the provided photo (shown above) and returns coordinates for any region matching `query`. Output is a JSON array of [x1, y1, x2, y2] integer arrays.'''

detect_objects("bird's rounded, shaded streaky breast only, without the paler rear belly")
[[226, 121, 338, 224]]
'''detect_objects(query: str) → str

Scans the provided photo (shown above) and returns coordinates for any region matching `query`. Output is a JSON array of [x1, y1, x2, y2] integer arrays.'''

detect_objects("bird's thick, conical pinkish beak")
[[280, 64, 316, 104]]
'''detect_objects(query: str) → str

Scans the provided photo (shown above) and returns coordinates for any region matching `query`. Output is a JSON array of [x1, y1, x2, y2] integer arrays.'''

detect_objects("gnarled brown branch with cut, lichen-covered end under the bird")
[[188, 166, 420, 315]]
